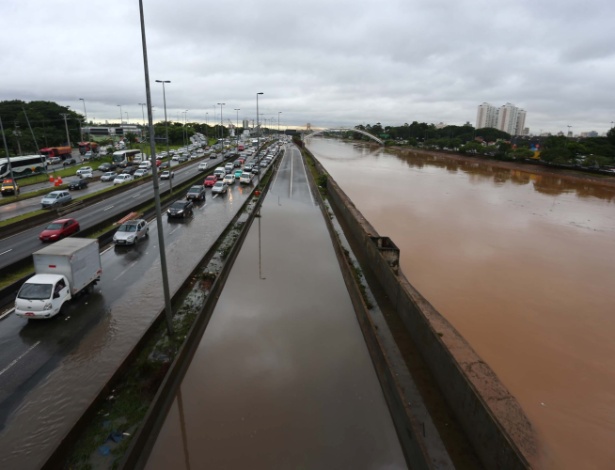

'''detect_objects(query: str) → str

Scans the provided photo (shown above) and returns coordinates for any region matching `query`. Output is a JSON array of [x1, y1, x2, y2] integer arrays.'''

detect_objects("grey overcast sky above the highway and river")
[[0, 0, 615, 134]]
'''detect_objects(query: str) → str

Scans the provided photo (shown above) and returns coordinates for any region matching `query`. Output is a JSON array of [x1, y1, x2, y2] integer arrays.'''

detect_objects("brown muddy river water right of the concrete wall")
[[308, 139, 615, 469]]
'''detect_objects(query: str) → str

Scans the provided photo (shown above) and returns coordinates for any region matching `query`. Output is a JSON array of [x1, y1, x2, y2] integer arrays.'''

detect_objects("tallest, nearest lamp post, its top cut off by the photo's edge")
[[139, 0, 173, 336]]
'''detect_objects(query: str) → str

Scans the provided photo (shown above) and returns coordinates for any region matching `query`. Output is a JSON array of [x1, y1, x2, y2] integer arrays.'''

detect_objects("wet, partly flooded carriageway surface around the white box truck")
[[0, 182, 255, 468]]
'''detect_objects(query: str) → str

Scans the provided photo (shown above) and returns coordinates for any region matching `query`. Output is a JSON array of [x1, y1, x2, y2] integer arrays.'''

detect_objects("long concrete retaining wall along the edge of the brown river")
[[305, 150, 538, 469]]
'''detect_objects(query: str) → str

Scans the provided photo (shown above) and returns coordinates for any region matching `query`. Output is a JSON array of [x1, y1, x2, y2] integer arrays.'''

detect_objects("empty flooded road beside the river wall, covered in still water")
[[147, 147, 406, 470]]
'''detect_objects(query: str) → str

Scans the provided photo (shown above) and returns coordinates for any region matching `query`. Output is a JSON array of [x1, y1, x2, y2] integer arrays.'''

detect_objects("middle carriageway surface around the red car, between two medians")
[[0, 159, 219, 267]]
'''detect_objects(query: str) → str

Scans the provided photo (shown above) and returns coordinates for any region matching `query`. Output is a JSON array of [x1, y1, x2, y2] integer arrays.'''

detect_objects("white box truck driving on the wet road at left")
[[15, 237, 102, 319]]
